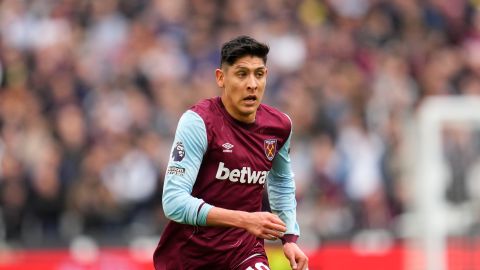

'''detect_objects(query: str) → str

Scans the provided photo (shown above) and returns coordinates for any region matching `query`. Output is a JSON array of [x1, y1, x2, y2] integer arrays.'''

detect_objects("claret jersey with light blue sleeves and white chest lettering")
[[154, 97, 299, 270]]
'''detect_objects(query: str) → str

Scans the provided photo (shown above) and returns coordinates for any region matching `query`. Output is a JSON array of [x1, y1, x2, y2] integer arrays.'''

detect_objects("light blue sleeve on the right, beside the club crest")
[[267, 127, 300, 235]]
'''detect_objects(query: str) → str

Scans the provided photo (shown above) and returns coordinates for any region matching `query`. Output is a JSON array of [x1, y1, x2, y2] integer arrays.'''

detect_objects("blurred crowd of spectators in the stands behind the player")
[[0, 0, 480, 247]]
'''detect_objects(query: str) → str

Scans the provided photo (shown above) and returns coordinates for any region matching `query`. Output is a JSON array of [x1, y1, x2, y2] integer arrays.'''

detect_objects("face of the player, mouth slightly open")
[[215, 56, 267, 123]]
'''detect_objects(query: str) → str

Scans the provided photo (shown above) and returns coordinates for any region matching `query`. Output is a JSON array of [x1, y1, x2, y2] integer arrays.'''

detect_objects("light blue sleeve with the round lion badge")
[[162, 110, 213, 226]]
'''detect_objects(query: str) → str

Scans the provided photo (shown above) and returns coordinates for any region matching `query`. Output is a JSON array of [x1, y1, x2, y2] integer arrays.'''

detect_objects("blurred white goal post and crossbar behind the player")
[[406, 96, 480, 270]]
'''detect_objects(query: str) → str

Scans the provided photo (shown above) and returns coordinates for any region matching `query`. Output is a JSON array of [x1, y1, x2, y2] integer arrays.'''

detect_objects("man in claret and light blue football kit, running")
[[154, 36, 308, 270]]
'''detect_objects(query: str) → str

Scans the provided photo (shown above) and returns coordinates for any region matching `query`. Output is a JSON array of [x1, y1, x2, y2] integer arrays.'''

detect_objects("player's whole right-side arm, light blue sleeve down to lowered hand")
[[267, 128, 308, 270]]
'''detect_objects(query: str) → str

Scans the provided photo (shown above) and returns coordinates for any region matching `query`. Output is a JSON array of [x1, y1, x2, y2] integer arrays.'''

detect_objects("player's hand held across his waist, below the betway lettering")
[[243, 212, 287, 240]]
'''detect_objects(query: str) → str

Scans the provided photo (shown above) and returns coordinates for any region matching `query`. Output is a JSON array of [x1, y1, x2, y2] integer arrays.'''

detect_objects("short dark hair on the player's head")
[[220, 36, 270, 66]]
